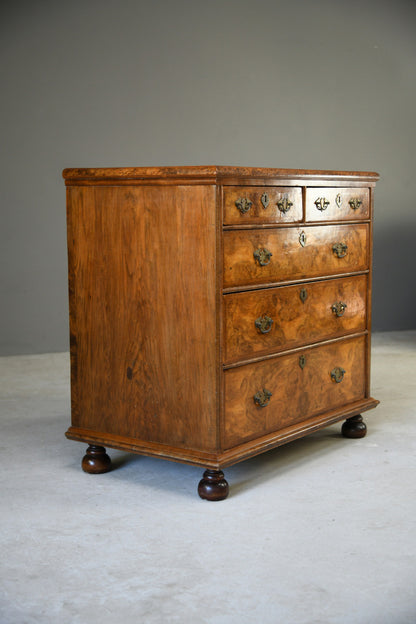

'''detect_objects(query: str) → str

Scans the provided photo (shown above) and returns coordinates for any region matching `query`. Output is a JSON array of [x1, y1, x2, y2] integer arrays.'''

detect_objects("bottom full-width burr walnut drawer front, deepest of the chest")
[[223, 337, 366, 449]]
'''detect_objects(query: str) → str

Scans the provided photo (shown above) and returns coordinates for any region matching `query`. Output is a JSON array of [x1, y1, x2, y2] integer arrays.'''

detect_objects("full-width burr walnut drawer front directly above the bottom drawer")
[[223, 275, 367, 363]]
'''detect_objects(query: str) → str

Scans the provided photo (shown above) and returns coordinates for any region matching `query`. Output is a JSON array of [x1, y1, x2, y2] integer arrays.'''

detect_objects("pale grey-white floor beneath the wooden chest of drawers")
[[0, 332, 416, 624]]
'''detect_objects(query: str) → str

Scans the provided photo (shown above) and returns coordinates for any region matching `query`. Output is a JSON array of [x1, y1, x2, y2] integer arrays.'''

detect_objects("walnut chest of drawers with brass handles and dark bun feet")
[[63, 166, 378, 500]]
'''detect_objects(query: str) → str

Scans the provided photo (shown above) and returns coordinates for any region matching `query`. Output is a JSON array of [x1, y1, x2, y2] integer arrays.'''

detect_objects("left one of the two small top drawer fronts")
[[223, 186, 302, 225]]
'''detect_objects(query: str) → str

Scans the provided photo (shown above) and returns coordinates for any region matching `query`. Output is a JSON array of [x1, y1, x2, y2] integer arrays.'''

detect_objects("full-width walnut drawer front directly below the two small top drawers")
[[224, 224, 368, 288]]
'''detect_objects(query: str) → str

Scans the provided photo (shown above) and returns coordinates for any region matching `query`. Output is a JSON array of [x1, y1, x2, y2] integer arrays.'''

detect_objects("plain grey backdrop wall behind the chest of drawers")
[[0, 0, 416, 354]]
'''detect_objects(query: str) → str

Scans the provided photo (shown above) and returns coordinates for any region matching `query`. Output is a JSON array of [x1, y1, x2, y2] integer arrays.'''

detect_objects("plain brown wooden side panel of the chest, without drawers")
[[68, 185, 217, 449]]
